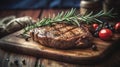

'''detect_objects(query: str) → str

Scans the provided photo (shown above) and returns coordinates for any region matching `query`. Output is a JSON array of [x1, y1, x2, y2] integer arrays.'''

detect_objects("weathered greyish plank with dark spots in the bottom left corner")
[[1, 52, 36, 67]]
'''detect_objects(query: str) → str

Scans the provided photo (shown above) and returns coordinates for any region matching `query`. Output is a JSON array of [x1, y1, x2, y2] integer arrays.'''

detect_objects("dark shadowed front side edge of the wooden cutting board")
[[0, 40, 116, 64]]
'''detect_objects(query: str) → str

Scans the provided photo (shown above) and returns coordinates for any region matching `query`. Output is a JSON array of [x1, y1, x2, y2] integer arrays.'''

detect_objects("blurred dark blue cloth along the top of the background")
[[0, 0, 80, 9]]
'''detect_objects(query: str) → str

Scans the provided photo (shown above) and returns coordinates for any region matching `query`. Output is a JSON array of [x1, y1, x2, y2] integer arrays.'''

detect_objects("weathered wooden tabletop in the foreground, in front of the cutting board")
[[0, 47, 120, 67]]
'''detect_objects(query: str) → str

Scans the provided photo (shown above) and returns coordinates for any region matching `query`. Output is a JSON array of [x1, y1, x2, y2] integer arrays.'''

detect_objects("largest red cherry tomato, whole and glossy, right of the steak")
[[99, 29, 113, 40]]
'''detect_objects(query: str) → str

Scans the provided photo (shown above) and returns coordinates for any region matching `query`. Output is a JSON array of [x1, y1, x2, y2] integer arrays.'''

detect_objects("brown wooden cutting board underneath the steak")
[[0, 31, 120, 64]]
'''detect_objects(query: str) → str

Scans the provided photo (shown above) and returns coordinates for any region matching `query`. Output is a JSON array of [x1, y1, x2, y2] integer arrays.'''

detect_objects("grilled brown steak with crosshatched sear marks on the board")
[[30, 23, 93, 49]]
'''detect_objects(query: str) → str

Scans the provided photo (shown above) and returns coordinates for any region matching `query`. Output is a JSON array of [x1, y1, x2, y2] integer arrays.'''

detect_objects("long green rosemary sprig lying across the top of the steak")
[[23, 8, 114, 34]]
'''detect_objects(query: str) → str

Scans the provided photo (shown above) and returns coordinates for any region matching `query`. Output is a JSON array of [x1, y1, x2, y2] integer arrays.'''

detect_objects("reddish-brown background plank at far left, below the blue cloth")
[[0, 9, 41, 20]]
